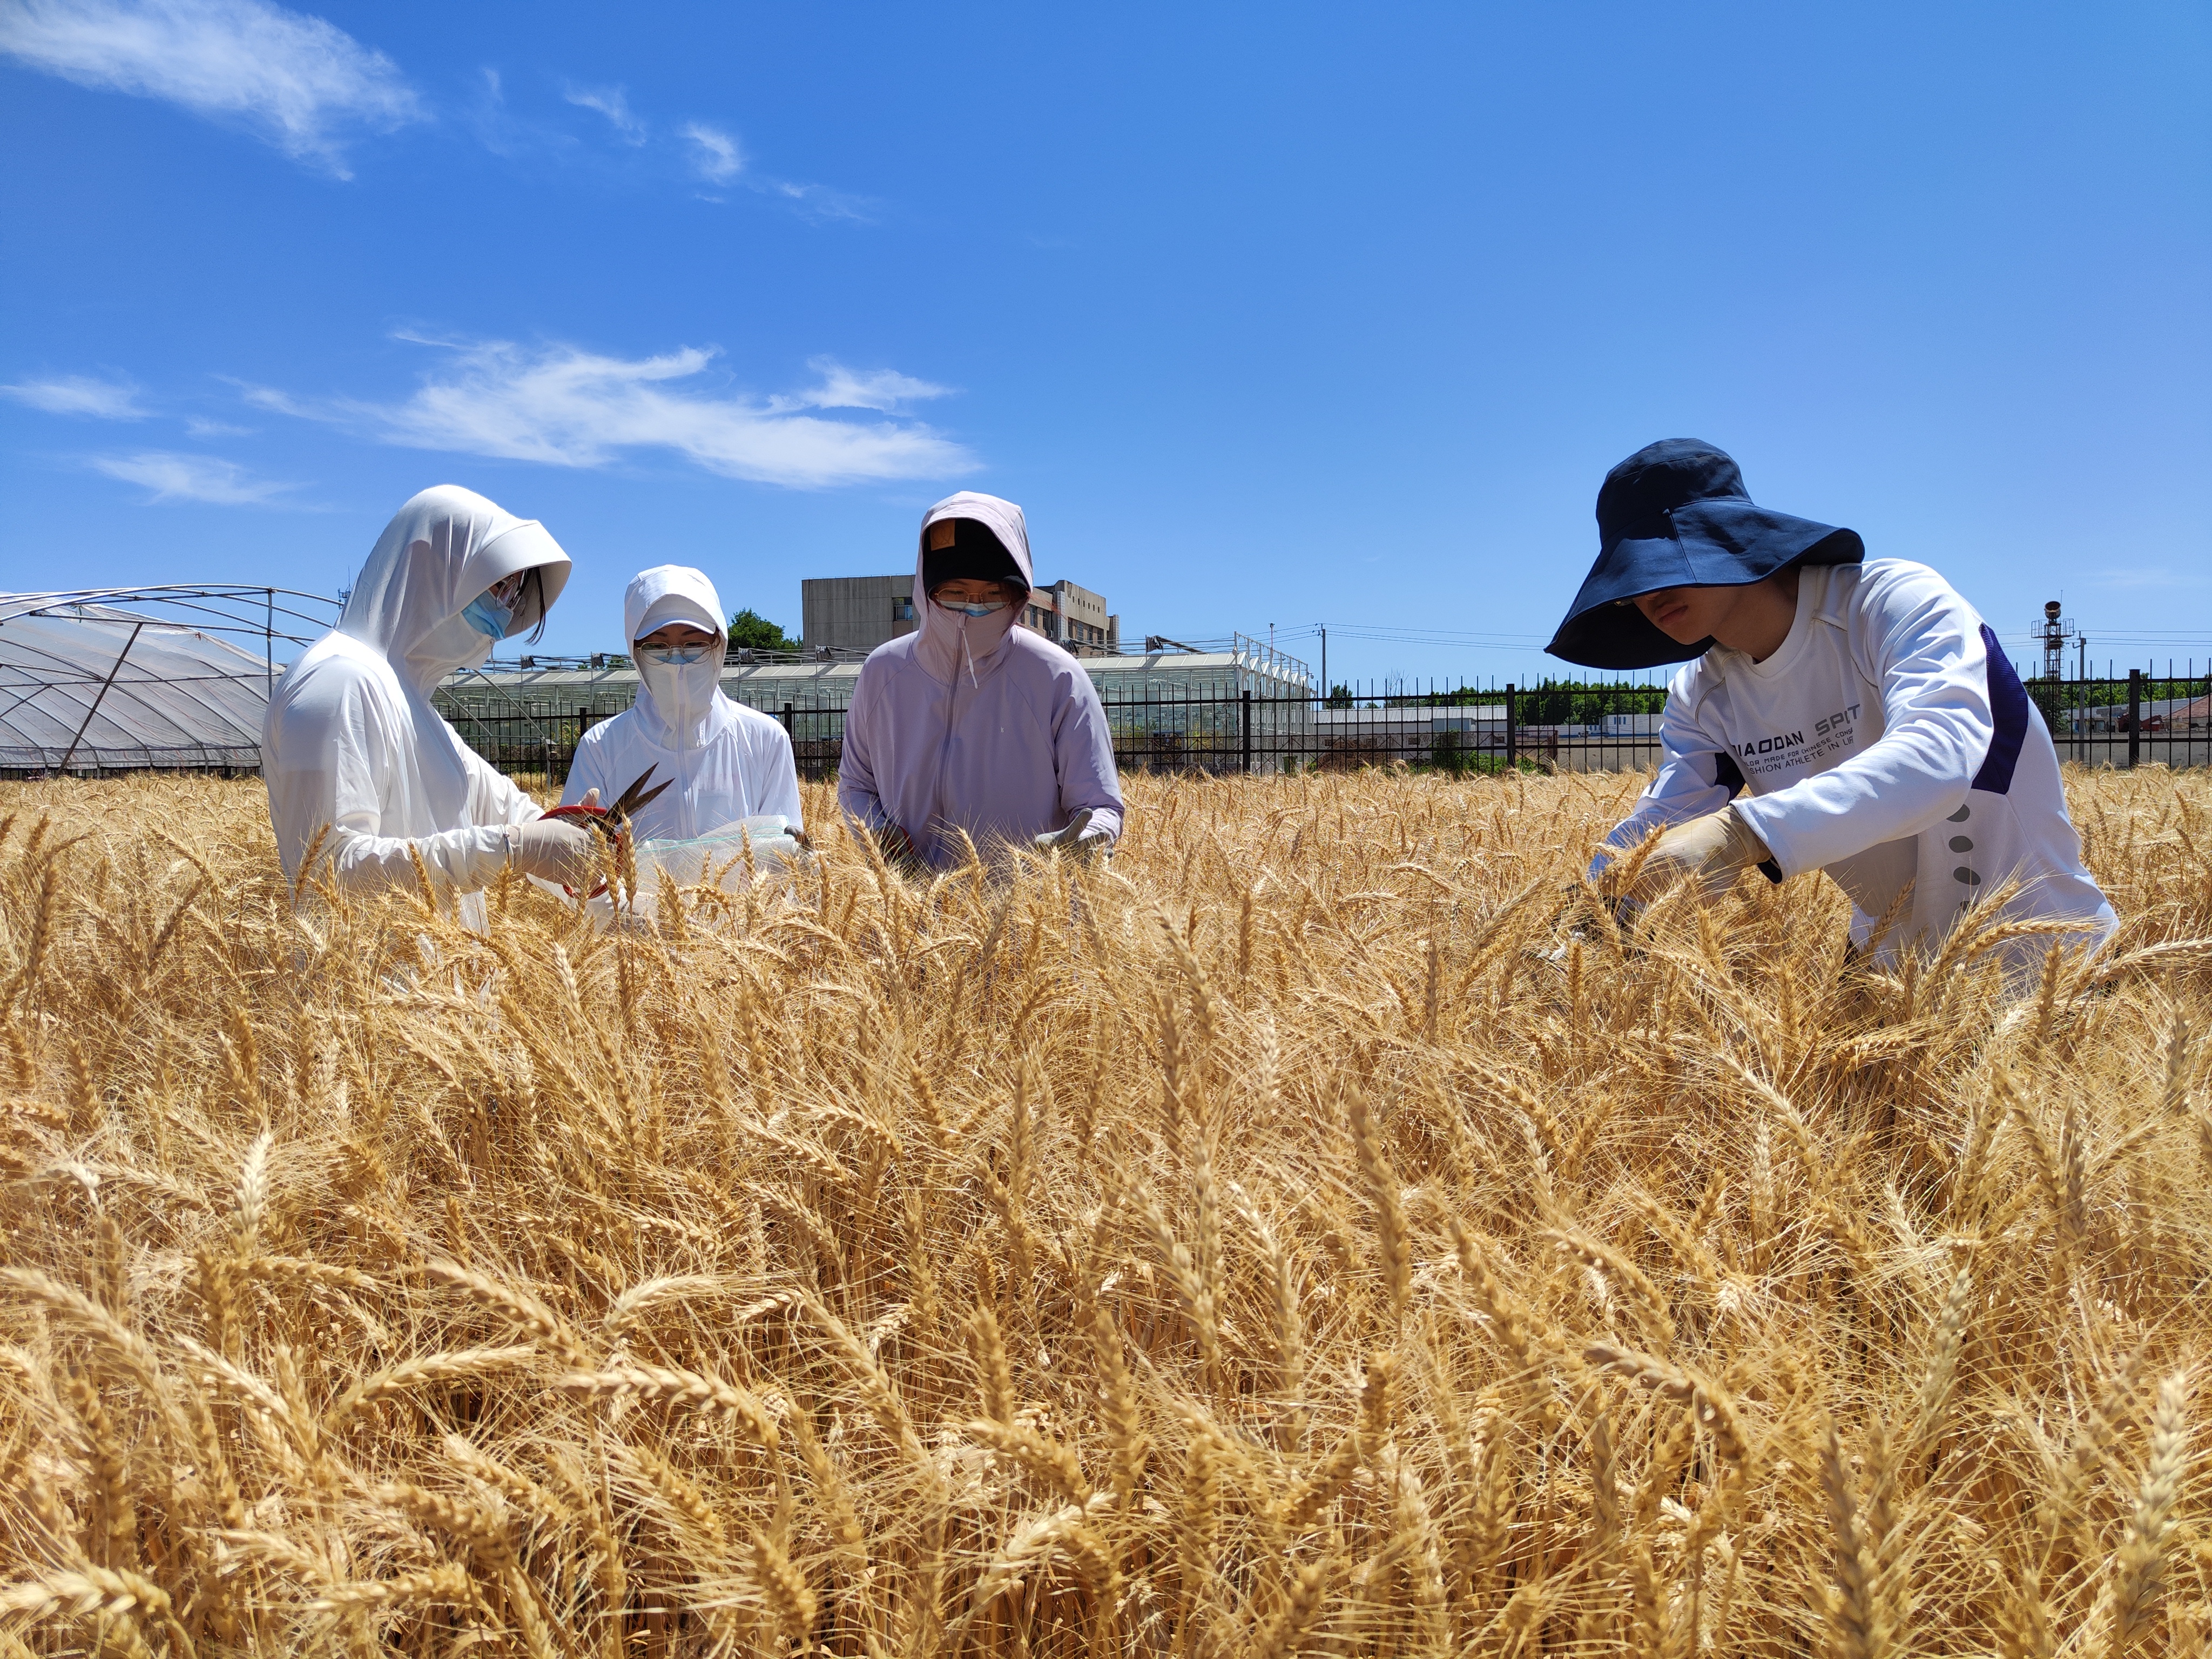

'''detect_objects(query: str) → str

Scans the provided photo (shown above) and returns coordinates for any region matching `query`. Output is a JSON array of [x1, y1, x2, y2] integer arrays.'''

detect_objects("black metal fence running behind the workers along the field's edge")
[[447, 672, 2212, 781]]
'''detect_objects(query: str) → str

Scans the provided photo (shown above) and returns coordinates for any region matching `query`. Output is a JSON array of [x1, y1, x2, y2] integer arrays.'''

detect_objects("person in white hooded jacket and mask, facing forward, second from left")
[[562, 564, 799, 840]]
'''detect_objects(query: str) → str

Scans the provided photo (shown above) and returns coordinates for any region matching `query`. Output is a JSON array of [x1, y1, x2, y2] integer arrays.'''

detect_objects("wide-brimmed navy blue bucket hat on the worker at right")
[[1544, 449, 1867, 668]]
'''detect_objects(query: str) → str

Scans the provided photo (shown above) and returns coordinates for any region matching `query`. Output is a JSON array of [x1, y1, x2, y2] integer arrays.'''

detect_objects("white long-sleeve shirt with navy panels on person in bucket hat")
[[1593, 559, 2115, 958]]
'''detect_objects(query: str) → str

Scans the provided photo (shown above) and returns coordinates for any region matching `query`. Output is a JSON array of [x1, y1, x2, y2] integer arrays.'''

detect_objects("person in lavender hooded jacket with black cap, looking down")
[[836, 491, 1122, 869]]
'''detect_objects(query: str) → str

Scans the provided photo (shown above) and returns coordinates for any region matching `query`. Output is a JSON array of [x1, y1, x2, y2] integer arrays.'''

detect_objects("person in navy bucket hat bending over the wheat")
[[1550, 438, 2115, 975]]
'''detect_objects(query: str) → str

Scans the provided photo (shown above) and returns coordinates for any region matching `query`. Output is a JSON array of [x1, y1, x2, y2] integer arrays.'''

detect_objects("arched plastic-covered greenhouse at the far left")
[[0, 586, 334, 777]]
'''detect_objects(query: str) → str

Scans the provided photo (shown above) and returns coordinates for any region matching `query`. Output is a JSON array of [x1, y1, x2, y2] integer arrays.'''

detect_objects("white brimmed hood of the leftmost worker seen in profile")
[[339, 484, 569, 697]]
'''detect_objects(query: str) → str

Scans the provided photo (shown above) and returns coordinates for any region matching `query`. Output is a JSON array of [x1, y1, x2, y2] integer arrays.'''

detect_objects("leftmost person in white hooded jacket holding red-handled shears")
[[261, 484, 595, 925]]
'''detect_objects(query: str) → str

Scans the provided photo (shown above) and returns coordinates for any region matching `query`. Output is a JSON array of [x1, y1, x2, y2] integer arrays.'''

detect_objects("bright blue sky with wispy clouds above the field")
[[0, 0, 2212, 682]]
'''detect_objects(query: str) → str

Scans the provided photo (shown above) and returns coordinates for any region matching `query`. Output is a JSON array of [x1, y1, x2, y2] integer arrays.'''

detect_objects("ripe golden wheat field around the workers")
[[0, 770, 2212, 1659]]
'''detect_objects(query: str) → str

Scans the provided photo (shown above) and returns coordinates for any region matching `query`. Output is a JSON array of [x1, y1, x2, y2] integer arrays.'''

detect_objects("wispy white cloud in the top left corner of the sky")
[[0, 0, 422, 179]]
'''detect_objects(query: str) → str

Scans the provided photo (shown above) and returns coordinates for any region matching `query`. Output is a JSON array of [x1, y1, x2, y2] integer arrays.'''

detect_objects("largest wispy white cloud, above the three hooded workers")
[[246, 341, 973, 489]]
